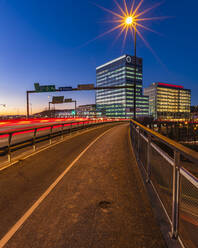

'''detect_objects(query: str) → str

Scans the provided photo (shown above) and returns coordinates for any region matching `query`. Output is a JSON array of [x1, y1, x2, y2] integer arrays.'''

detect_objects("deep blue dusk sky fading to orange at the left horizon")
[[0, 0, 198, 114]]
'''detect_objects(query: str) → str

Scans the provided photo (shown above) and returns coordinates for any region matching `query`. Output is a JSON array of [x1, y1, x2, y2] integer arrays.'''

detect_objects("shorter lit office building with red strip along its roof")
[[144, 83, 191, 120]]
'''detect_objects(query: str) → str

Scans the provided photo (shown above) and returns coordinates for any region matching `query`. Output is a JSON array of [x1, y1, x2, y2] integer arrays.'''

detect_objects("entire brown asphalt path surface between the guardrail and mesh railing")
[[0, 124, 166, 248]]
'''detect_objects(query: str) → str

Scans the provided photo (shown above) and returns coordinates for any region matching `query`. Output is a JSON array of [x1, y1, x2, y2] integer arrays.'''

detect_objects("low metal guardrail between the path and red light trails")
[[0, 119, 115, 162]]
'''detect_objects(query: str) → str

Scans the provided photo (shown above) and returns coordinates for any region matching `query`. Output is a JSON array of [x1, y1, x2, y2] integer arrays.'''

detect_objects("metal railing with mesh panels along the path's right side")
[[130, 120, 198, 248]]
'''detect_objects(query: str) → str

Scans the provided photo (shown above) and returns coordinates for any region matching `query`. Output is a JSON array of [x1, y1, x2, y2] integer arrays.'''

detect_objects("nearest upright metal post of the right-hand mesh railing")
[[171, 150, 180, 239]]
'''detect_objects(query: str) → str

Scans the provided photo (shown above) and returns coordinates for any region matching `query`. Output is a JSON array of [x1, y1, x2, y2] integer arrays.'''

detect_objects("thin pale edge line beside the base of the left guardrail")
[[0, 123, 114, 171]]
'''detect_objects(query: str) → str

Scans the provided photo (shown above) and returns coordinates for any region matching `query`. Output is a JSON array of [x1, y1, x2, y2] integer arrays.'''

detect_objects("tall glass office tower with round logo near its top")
[[96, 55, 149, 118]]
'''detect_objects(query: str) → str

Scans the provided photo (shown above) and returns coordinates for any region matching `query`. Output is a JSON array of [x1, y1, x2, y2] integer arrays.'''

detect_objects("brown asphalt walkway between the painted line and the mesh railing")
[[2, 124, 166, 248]]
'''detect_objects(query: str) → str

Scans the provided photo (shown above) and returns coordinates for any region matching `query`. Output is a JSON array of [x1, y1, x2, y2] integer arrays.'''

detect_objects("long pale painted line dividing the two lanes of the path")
[[0, 127, 115, 248]]
